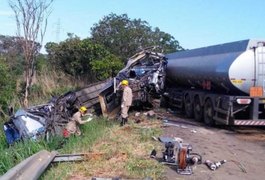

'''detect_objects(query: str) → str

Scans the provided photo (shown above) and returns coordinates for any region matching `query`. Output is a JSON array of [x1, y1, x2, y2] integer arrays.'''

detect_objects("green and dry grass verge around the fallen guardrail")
[[0, 114, 164, 180]]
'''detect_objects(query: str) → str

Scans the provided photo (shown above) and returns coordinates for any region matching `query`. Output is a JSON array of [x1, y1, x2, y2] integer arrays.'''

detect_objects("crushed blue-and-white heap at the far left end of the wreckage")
[[4, 92, 76, 145]]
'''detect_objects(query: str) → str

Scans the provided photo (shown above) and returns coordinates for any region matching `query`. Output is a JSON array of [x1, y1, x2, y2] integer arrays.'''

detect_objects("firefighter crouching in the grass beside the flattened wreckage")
[[63, 106, 92, 137]]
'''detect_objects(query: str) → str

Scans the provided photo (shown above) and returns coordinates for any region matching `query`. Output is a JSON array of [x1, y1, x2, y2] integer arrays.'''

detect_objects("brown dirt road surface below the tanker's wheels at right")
[[158, 113, 265, 180]]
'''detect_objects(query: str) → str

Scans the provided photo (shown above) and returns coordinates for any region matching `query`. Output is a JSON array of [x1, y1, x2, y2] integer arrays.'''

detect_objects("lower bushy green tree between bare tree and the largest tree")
[[45, 34, 122, 82]]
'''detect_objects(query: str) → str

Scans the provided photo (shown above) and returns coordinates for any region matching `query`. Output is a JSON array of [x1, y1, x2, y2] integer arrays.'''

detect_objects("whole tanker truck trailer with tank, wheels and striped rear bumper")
[[161, 40, 265, 126]]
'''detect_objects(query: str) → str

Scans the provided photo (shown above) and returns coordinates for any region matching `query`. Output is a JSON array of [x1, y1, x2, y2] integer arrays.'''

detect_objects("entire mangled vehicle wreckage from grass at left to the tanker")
[[4, 48, 167, 144]]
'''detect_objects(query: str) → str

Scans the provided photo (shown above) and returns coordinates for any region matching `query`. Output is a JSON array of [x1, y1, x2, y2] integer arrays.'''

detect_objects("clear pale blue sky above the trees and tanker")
[[0, 0, 265, 51]]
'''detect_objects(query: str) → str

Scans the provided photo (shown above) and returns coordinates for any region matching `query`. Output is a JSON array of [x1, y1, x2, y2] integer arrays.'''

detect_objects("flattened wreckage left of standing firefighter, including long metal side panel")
[[4, 81, 106, 145]]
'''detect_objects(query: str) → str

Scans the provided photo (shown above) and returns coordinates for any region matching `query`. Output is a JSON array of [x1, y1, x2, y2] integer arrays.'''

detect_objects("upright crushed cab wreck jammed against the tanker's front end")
[[99, 47, 167, 118]]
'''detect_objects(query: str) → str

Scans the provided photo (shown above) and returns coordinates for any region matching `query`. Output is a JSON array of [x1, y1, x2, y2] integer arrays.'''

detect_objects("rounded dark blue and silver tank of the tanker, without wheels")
[[166, 40, 265, 95]]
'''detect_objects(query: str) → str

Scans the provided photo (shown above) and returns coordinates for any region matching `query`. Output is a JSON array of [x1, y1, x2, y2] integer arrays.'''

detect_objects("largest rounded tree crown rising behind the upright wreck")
[[91, 13, 183, 60]]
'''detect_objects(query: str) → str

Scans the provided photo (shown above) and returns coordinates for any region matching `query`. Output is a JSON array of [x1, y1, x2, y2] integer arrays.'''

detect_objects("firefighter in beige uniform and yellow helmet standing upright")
[[120, 80, 133, 126]]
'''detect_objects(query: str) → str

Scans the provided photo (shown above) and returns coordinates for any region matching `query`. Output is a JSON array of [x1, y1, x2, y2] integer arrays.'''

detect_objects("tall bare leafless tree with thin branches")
[[9, 0, 53, 107]]
